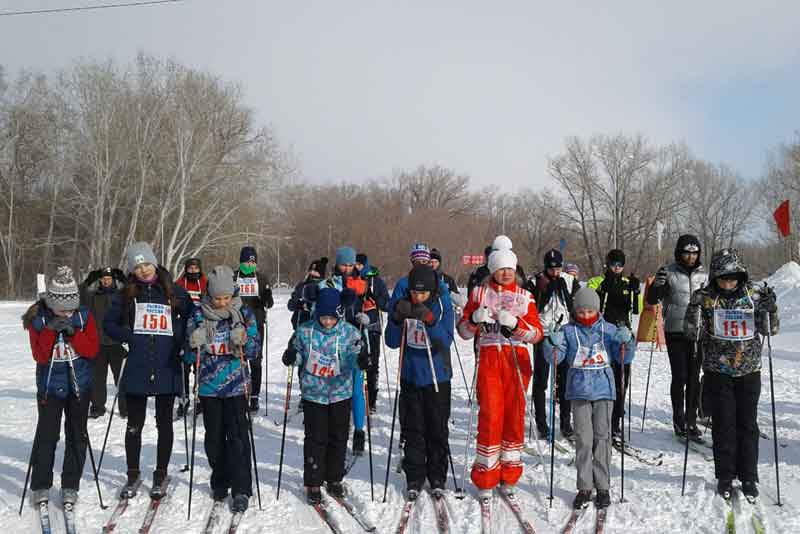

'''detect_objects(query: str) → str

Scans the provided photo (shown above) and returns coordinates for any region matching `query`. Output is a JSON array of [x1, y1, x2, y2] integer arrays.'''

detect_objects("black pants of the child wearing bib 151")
[[705, 372, 761, 482]]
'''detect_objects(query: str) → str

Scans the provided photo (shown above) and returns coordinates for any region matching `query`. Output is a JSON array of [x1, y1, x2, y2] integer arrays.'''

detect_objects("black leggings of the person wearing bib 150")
[[125, 395, 175, 473]]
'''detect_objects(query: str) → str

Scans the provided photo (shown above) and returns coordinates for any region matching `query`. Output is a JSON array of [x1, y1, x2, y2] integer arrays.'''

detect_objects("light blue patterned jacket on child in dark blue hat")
[[294, 320, 361, 404]]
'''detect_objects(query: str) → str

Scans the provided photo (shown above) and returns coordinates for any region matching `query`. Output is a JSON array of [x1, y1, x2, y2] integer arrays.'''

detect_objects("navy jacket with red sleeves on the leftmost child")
[[23, 301, 100, 399]]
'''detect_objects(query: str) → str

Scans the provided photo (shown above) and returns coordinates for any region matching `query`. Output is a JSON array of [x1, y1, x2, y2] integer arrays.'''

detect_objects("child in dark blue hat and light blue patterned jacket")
[[282, 288, 369, 504]]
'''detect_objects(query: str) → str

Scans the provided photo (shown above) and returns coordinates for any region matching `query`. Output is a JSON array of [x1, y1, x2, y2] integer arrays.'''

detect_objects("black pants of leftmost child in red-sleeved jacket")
[[31, 396, 89, 491]]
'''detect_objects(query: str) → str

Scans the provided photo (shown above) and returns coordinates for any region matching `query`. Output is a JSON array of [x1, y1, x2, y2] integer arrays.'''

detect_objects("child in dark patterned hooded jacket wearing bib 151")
[[684, 249, 778, 500]]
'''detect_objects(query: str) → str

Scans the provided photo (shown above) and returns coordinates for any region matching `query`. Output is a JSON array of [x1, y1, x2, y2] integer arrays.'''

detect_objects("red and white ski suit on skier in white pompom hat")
[[458, 279, 542, 489]]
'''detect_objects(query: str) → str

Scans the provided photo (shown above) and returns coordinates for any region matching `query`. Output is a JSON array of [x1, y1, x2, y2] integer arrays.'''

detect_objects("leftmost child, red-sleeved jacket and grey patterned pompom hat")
[[22, 267, 100, 504]]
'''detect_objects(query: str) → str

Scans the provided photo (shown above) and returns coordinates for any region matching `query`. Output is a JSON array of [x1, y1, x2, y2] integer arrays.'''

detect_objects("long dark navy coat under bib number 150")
[[103, 267, 194, 395]]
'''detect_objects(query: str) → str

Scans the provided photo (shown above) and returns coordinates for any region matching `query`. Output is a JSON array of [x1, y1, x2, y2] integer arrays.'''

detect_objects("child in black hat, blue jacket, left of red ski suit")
[[386, 265, 453, 500]]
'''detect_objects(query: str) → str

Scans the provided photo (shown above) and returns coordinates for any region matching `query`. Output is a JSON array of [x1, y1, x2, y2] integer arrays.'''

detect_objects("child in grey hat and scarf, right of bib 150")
[[184, 265, 259, 512]]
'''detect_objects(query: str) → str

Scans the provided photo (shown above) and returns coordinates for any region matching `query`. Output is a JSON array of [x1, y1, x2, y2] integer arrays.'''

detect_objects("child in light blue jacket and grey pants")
[[545, 287, 633, 509]]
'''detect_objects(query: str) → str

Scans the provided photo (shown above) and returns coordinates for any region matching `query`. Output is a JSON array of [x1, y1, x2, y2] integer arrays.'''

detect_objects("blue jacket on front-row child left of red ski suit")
[[386, 295, 453, 387]]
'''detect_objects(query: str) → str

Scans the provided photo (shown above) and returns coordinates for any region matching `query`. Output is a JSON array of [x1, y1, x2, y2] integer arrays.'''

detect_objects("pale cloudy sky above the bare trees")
[[0, 0, 800, 190]]
